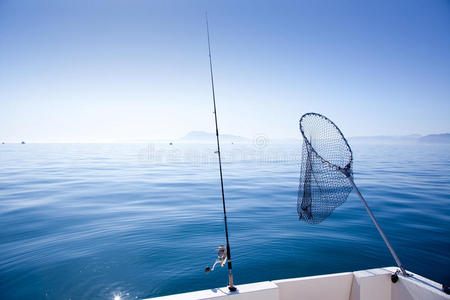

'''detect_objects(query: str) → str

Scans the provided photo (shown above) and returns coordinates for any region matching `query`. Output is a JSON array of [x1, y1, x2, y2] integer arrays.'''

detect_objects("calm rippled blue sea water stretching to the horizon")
[[0, 144, 450, 299]]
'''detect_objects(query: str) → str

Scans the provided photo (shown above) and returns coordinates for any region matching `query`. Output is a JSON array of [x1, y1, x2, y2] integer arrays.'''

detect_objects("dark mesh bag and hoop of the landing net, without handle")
[[297, 113, 353, 224]]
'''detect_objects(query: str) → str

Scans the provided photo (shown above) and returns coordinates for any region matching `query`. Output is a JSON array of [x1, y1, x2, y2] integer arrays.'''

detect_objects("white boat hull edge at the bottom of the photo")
[[146, 267, 450, 300]]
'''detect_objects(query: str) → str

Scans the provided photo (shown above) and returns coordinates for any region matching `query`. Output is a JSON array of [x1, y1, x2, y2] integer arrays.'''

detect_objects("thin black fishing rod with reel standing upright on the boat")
[[205, 13, 236, 292]]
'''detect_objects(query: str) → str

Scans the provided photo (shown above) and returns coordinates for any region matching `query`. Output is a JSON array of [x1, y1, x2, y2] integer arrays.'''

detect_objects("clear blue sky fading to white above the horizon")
[[0, 0, 450, 142]]
